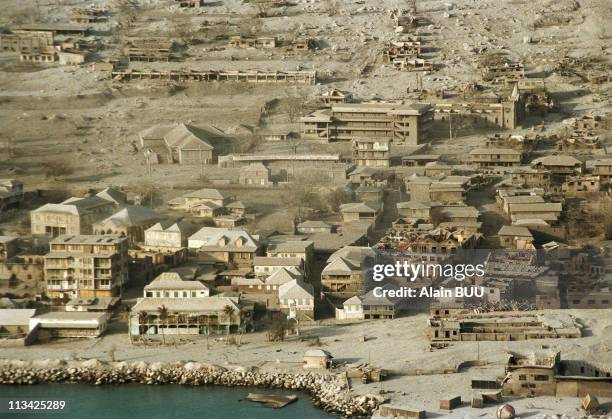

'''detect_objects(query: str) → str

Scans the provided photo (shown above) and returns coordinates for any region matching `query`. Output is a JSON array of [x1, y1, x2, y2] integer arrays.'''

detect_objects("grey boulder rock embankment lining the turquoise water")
[[0, 359, 383, 417]]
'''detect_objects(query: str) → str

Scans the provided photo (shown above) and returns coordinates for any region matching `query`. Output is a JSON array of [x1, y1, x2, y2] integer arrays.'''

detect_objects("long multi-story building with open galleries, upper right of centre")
[[301, 103, 433, 145]]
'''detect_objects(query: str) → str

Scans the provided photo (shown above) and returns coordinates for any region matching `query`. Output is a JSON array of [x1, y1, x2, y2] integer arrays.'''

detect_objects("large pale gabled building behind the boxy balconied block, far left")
[[30, 196, 115, 238]]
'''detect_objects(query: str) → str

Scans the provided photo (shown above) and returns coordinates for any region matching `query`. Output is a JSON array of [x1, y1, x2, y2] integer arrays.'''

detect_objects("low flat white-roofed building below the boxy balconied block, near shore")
[[29, 311, 108, 339]]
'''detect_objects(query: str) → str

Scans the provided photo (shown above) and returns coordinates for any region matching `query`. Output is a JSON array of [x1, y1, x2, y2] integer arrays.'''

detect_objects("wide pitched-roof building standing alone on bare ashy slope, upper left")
[[140, 124, 226, 165]]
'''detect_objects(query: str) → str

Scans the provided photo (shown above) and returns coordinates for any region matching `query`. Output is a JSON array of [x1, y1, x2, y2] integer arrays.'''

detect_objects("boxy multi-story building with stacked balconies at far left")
[[44, 235, 128, 298]]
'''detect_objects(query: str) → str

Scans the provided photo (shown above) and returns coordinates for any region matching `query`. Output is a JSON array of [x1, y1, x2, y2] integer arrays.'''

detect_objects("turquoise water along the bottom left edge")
[[0, 384, 335, 419]]
